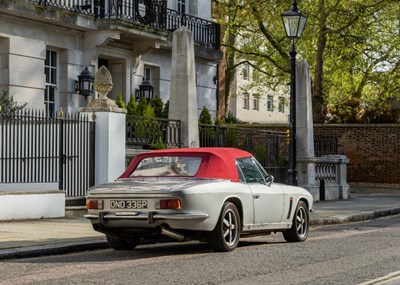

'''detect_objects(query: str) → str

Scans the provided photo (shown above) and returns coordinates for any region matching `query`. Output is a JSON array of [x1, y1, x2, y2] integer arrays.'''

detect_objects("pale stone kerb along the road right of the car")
[[310, 208, 400, 226]]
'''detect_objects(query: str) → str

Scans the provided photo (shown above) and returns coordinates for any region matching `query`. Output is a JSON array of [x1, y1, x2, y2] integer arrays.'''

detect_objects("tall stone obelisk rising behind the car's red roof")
[[168, 27, 199, 147]]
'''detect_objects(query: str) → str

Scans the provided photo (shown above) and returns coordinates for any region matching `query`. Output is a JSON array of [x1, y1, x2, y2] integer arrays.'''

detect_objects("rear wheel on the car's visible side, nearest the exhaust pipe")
[[208, 202, 241, 252]]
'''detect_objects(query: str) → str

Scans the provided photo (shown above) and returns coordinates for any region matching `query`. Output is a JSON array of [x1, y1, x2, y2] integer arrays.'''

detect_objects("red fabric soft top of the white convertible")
[[119, 147, 252, 182]]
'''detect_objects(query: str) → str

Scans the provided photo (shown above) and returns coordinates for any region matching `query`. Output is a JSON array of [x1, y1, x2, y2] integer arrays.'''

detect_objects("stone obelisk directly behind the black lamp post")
[[296, 60, 318, 194]]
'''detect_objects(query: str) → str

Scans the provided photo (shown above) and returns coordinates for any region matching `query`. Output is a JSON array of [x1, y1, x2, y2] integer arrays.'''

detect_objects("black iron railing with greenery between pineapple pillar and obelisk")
[[126, 115, 181, 149]]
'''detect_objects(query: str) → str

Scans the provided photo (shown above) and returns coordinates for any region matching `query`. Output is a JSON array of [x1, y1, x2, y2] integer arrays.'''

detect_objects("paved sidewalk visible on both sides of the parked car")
[[0, 188, 400, 259]]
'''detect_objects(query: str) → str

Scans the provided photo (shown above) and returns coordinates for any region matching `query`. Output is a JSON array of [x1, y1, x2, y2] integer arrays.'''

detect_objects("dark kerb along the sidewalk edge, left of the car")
[[0, 239, 109, 260]]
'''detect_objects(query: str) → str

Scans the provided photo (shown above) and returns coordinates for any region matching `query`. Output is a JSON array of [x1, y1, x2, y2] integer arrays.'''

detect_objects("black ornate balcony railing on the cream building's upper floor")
[[29, 0, 220, 49]]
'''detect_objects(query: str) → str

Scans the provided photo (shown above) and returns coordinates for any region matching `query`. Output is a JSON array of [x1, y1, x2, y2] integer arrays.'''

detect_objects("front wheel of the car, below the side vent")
[[283, 201, 310, 242]]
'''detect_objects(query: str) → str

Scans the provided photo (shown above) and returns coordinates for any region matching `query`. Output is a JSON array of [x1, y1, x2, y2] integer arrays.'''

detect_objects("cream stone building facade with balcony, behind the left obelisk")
[[0, 0, 222, 115]]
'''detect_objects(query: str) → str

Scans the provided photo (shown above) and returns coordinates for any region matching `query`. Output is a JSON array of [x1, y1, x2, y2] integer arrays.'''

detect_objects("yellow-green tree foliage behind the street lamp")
[[213, 0, 400, 122]]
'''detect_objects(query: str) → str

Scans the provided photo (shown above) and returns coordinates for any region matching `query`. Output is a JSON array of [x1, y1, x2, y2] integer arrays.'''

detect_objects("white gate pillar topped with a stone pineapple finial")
[[80, 66, 126, 185]]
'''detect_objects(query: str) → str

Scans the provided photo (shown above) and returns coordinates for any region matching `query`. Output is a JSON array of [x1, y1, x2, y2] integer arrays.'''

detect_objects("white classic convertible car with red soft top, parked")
[[85, 148, 313, 251]]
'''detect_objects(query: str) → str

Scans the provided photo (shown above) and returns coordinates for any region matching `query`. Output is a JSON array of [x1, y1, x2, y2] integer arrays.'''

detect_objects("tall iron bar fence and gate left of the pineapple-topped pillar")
[[0, 110, 94, 197]]
